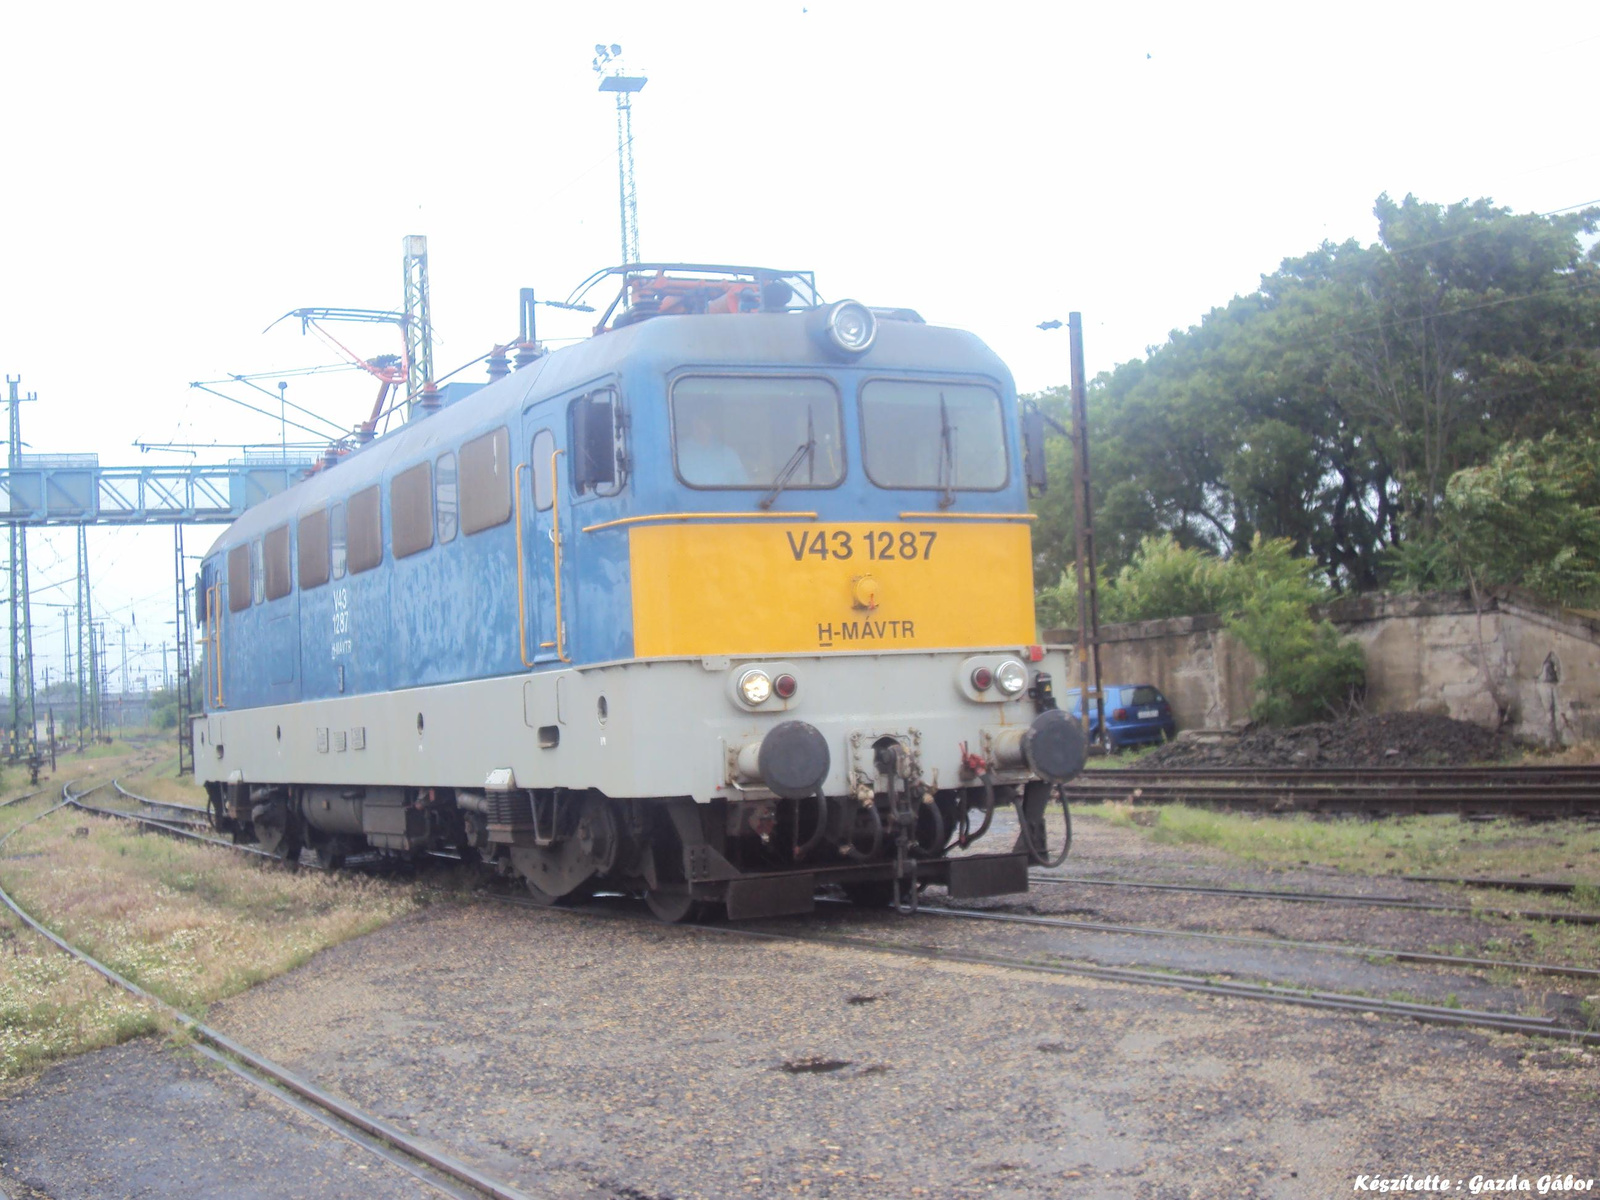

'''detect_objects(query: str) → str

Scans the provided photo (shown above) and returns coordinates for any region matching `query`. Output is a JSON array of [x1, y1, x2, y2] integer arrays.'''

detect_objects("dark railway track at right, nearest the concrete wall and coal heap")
[[1067, 766, 1600, 819]]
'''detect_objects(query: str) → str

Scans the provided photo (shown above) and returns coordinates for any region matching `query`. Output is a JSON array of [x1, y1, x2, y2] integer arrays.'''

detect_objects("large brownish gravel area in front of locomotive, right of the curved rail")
[[200, 902, 1600, 1200]]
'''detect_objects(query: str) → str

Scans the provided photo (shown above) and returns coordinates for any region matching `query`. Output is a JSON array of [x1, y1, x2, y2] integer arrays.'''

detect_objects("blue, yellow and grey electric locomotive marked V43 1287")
[[192, 266, 1085, 920]]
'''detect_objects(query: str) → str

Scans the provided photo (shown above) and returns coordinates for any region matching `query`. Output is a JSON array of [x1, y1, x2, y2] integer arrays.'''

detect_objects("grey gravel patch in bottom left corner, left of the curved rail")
[[0, 1040, 437, 1200]]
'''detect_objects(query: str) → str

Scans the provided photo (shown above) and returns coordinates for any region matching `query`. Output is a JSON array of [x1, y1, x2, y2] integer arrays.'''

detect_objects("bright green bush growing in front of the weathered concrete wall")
[[1224, 534, 1366, 725]]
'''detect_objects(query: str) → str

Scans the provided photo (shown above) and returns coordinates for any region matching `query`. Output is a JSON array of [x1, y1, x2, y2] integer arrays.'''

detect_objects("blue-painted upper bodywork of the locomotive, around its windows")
[[202, 314, 1027, 710]]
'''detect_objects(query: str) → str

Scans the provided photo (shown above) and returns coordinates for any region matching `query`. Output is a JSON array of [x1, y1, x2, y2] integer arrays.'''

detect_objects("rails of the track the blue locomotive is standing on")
[[62, 781, 1600, 1045]]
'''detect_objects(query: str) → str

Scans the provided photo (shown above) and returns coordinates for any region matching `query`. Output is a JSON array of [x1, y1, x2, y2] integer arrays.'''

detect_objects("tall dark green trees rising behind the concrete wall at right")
[[1035, 195, 1600, 598]]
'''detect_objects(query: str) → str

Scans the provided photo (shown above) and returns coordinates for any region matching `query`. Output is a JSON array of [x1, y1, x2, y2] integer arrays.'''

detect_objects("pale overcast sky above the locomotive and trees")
[[0, 0, 1600, 686]]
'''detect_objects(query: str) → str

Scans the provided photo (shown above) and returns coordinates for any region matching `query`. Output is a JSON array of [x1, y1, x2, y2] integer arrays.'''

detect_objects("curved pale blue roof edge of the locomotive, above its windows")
[[206, 312, 1011, 558]]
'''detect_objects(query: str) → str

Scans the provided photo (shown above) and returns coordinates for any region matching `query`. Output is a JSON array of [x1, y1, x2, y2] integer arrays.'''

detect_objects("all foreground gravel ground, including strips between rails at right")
[[0, 822, 1600, 1200]]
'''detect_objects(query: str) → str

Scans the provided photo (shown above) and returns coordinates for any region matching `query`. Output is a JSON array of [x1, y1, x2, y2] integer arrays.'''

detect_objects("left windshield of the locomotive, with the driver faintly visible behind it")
[[672, 374, 845, 488]]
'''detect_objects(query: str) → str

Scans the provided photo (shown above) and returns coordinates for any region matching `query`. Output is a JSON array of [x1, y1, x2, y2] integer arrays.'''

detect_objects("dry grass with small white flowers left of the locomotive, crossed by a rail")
[[0, 776, 466, 1080]]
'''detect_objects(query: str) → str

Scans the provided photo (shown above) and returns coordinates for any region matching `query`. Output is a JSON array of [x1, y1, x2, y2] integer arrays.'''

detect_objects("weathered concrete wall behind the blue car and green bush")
[[1046, 590, 1600, 746]]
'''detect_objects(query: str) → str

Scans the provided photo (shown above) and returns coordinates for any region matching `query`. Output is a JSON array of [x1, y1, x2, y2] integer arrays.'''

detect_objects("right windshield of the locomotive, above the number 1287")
[[861, 379, 1006, 491]]
